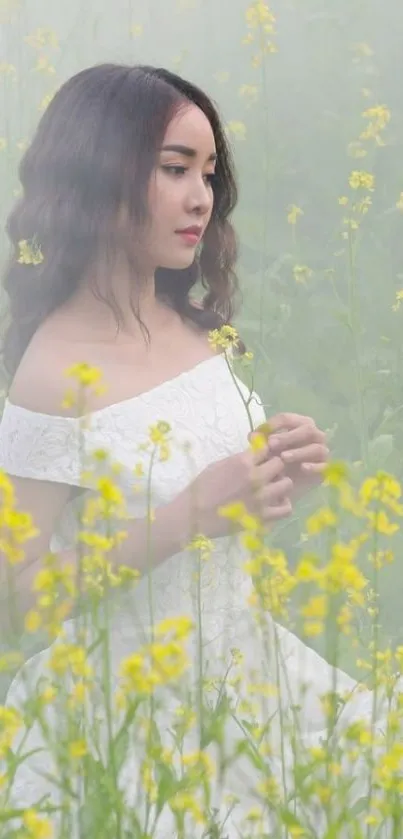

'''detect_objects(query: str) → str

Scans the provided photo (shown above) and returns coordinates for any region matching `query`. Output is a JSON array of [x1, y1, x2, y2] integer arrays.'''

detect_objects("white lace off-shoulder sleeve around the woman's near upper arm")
[[0, 400, 82, 486]]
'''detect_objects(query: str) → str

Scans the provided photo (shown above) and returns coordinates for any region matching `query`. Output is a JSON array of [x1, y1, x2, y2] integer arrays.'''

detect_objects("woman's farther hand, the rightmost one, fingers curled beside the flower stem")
[[256, 413, 330, 501]]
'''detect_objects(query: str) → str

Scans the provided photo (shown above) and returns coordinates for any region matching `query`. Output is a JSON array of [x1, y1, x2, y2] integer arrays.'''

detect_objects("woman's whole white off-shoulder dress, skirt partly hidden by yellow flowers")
[[0, 355, 400, 839]]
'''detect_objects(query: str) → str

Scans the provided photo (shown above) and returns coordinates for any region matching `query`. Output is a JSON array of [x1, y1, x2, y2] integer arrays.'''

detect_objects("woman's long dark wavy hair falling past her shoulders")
[[2, 64, 243, 377]]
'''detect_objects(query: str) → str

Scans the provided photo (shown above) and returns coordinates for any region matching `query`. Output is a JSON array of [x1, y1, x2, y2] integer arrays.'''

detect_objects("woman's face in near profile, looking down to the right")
[[147, 105, 216, 269]]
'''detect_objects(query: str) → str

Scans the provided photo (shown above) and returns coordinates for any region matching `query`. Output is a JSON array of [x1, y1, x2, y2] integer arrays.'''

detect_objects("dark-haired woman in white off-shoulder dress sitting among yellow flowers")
[[0, 65, 390, 837]]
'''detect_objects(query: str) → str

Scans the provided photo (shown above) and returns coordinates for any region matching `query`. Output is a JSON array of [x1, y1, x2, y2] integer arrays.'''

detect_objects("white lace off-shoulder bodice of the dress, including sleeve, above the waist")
[[0, 354, 265, 547]]
